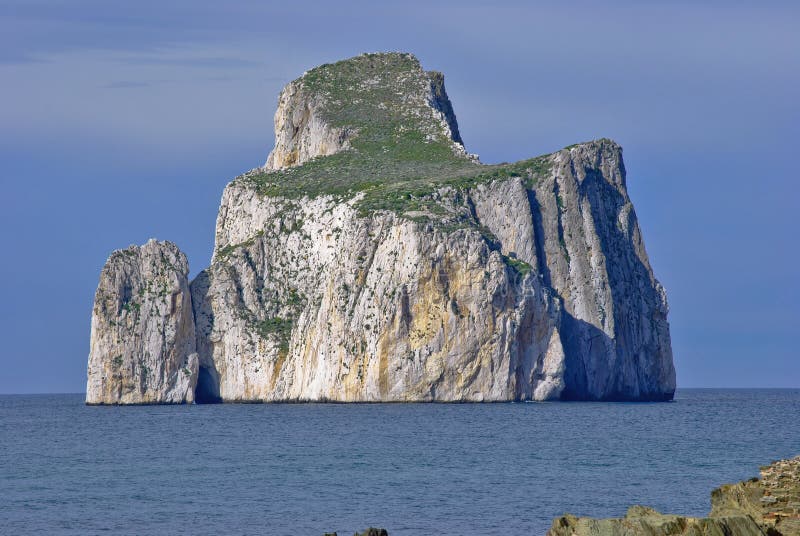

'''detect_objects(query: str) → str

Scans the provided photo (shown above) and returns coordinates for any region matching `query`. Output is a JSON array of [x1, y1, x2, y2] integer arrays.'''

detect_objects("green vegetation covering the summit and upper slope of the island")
[[238, 50, 552, 215]]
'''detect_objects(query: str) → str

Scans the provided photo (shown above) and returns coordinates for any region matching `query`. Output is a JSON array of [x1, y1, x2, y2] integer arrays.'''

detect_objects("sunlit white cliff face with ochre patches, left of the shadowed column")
[[192, 188, 564, 401]]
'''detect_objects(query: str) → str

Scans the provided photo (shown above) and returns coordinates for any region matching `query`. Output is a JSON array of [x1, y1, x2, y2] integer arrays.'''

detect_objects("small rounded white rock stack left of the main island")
[[86, 240, 198, 404]]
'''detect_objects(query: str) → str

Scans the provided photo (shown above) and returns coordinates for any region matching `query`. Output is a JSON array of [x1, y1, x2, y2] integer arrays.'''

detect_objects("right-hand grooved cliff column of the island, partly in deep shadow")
[[532, 140, 675, 400]]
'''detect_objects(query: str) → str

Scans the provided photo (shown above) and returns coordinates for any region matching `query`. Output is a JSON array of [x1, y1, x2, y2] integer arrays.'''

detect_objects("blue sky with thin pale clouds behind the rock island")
[[0, 0, 800, 393]]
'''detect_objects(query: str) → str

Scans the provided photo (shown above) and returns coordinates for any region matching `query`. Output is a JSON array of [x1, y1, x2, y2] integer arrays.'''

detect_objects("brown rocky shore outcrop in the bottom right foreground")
[[547, 456, 800, 536]]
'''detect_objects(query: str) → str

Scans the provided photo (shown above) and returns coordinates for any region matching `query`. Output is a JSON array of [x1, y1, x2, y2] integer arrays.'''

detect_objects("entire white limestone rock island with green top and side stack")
[[86, 53, 675, 404]]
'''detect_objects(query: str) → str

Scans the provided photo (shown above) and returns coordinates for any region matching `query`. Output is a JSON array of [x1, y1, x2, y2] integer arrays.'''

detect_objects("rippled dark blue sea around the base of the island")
[[0, 389, 800, 536]]
